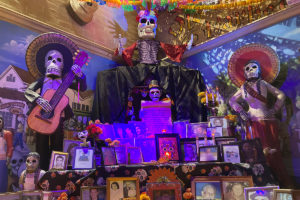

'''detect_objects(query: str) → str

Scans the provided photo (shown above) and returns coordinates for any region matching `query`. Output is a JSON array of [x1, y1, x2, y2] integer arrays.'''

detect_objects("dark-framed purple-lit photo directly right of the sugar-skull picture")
[[180, 138, 198, 162]]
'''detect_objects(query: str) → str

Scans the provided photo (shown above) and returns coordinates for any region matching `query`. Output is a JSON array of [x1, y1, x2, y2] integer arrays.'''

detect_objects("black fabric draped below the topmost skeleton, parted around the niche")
[[92, 62, 206, 123]]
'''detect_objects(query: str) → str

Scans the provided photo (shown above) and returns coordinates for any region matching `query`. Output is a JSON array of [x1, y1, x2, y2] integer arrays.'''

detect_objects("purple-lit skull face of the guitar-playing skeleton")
[[45, 50, 64, 77]]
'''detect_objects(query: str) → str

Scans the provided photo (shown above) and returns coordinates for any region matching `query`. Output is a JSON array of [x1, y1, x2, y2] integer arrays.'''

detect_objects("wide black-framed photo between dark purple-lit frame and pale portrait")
[[199, 146, 219, 162]]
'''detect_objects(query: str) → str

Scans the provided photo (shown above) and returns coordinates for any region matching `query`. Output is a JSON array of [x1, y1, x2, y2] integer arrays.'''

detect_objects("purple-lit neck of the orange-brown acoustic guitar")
[[49, 71, 75, 109]]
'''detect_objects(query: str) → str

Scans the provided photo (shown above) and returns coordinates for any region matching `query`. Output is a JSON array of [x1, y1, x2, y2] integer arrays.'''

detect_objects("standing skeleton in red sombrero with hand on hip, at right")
[[228, 44, 290, 188]]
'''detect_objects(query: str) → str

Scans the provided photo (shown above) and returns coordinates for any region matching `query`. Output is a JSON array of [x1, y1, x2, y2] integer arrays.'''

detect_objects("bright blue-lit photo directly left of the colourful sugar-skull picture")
[[135, 138, 156, 162]]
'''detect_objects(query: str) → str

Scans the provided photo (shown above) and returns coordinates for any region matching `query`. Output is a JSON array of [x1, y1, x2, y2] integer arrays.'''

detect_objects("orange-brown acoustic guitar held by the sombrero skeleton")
[[27, 51, 88, 135]]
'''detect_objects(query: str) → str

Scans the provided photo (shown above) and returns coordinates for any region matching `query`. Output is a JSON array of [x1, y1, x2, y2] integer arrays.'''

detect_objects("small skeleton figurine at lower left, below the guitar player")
[[19, 152, 46, 190]]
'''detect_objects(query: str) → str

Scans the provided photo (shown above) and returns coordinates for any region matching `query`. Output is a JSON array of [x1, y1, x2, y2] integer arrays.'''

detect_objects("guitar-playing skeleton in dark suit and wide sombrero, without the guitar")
[[25, 33, 87, 170]]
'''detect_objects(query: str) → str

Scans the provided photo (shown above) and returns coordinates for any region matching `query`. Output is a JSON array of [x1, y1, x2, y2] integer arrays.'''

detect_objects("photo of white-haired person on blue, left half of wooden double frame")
[[195, 181, 222, 200]]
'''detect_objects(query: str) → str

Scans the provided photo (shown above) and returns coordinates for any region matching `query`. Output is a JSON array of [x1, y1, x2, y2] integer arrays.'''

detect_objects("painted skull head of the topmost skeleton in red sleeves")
[[137, 10, 157, 39]]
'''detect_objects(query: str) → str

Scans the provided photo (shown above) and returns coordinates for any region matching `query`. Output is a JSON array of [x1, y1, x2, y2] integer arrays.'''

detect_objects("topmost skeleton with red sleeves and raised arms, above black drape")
[[116, 10, 193, 66]]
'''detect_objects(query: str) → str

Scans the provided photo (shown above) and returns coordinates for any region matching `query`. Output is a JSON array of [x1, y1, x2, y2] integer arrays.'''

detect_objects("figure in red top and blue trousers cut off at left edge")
[[0, 116, 13, 193]]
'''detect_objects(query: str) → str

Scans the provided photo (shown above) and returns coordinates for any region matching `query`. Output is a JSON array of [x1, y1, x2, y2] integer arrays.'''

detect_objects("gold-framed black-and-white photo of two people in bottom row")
[[106, 177, 140, 200]]
